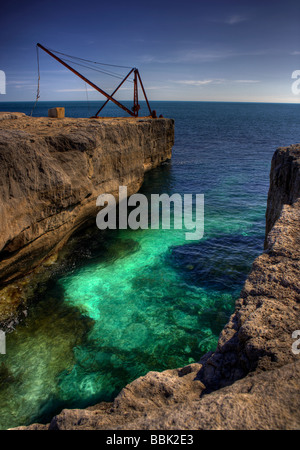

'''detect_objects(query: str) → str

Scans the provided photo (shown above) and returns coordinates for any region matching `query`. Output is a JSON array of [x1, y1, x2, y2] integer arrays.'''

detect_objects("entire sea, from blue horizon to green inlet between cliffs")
[[0, 102, 300, 428]]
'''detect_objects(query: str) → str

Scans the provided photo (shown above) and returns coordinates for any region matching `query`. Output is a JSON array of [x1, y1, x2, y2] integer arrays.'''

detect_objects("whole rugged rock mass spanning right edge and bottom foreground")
[[9, 145, 300, 430]]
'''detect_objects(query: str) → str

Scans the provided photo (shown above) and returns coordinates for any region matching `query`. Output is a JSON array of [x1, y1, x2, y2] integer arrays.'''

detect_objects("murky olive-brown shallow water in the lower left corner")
[[0, 289, 92, 429]]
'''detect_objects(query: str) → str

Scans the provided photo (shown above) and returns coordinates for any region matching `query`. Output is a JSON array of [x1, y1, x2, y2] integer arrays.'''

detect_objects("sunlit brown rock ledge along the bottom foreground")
[[18, 361, 300, 430]]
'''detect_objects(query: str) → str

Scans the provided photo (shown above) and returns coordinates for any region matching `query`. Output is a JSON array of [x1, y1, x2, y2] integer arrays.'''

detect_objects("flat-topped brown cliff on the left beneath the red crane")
[[0, 115, 174, 285]]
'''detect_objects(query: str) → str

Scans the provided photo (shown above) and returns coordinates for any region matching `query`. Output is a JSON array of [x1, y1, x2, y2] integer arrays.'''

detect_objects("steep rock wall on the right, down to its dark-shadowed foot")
[[199, 145, 300, 390]]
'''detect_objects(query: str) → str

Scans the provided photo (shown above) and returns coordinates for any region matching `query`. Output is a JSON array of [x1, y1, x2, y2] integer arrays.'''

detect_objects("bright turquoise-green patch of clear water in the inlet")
[[55, 223, 244, 401]]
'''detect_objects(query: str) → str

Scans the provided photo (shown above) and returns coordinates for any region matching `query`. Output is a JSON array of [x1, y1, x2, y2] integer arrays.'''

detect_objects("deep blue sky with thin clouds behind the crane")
[[0, 0, 300, 103]]
